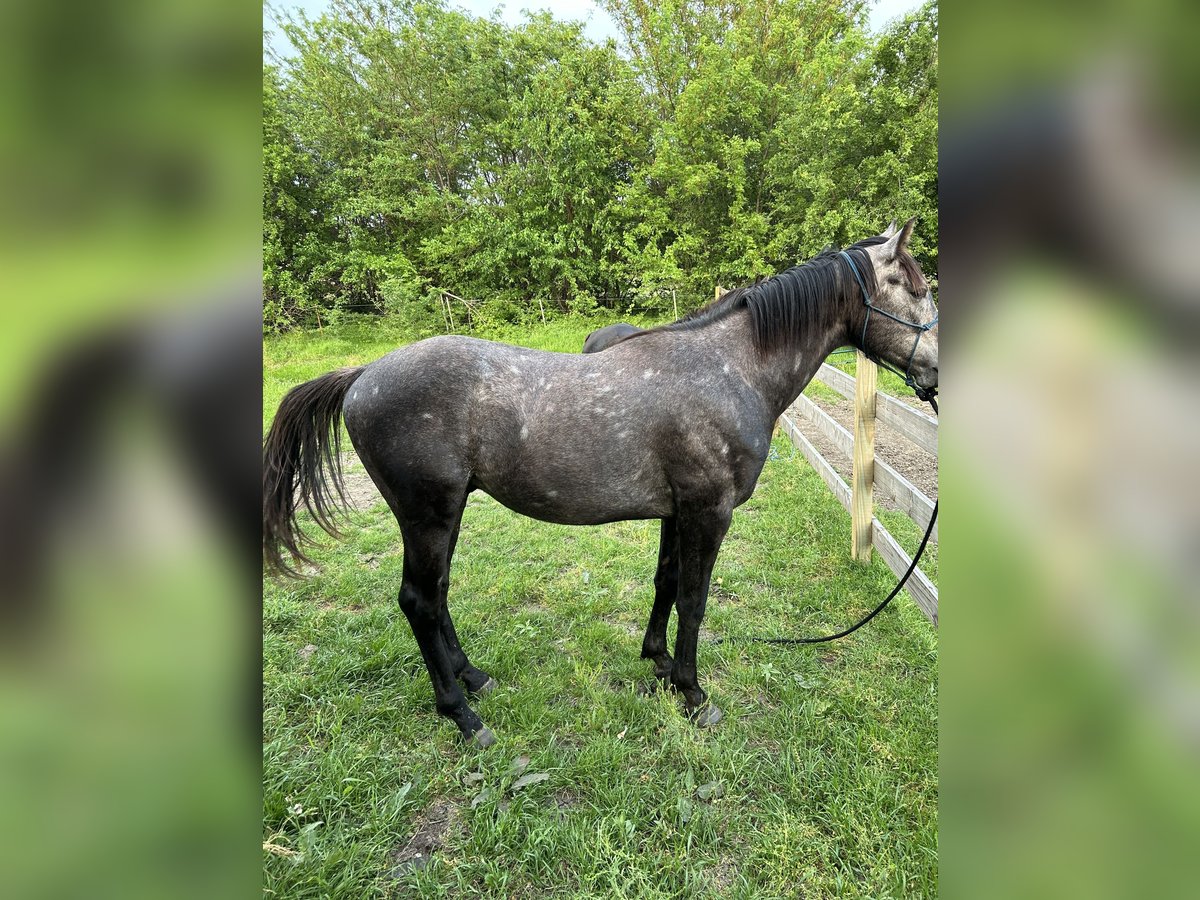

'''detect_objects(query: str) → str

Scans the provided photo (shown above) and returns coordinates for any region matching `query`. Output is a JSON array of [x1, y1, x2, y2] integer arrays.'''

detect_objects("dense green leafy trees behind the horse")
[[263, 0, 937, 331]]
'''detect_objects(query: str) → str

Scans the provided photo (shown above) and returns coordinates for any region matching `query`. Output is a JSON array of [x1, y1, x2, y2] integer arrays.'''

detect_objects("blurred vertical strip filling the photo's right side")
[[938, 2, 1200, 898]]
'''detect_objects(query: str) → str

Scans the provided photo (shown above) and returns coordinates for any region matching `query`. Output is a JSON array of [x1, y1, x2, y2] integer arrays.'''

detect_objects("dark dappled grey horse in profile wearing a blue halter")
[[263, 220, 937, 748]]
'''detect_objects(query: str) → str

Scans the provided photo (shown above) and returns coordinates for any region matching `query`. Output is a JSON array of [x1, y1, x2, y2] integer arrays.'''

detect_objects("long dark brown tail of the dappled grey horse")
[[263, 366, 364, 576]]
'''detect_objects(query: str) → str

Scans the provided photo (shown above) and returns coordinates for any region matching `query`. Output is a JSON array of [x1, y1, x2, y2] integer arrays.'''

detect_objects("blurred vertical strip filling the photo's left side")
[[0, 0, 262, 898]]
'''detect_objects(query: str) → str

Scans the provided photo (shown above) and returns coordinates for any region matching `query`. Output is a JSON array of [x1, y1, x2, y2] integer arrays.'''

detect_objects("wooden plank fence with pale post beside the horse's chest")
[[780, 353, 937, 626]]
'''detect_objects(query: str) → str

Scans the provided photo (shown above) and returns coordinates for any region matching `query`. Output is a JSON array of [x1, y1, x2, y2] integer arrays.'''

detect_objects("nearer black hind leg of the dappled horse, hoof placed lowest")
[[400, 523, 496, 746]]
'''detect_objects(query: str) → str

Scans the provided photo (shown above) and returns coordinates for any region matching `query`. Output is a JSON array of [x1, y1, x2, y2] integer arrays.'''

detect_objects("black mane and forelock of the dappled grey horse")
[[623, 235, 924, 353]]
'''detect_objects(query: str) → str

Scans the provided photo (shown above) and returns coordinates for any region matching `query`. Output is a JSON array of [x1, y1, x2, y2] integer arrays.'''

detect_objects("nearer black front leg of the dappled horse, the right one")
[[671, 504, 732, 726]]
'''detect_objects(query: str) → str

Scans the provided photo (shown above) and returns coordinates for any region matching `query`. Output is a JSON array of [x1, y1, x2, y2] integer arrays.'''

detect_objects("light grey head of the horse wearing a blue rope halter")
[[852, 218, 937, 400]]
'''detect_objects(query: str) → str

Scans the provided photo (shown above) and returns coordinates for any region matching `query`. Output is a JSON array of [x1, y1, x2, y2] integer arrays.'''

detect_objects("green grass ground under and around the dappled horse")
[[263, 314, 937, 898]]
